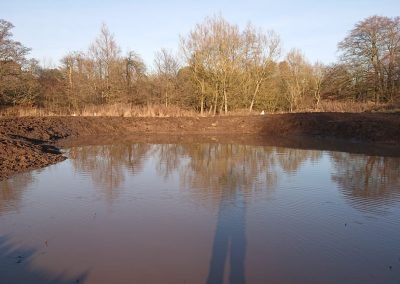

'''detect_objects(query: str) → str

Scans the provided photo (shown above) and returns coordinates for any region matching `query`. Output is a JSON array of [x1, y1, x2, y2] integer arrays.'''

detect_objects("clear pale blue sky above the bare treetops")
[[0, 0, 400, 67]]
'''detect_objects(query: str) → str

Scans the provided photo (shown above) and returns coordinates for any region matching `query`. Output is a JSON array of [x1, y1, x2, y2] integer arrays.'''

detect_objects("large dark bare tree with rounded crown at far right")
[[339, 16, 400, 103]]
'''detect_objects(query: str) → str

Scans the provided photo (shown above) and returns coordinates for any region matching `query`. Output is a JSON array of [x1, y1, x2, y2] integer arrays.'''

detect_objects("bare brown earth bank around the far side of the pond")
[[0, 113, 400, 179]]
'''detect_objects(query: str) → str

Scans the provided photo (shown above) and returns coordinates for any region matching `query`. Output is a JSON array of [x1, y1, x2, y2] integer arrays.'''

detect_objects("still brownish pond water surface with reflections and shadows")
[[0, 143, 400, 284]]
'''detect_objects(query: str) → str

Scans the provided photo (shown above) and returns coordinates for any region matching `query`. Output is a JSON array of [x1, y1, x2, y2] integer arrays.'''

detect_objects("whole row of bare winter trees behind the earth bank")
[[0, 16, 400, 115]]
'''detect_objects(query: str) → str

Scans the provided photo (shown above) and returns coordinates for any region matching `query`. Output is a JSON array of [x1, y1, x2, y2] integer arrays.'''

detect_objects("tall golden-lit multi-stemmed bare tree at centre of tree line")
[[182, 16, 243, 114]]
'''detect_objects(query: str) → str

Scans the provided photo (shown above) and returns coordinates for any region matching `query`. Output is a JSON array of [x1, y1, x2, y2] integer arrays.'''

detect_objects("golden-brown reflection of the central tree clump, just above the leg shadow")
[[177, 144, 277, 204]]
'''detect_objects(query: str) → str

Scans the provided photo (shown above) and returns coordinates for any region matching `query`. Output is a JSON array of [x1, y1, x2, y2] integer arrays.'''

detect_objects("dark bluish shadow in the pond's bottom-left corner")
[[0, 236, 88, 284]]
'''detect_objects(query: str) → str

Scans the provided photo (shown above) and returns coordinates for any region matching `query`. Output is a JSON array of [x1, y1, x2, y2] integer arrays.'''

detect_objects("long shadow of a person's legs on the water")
[[207, 191, 246, 284]]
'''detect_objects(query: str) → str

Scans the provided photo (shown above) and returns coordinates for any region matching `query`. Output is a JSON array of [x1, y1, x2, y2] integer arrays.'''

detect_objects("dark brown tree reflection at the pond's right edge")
[[331, 152, 400, 215]]
